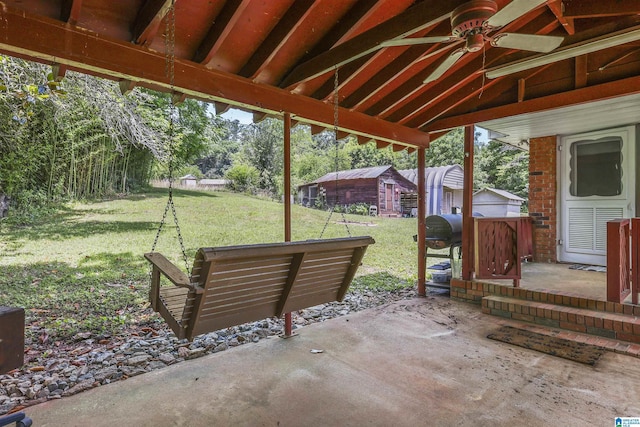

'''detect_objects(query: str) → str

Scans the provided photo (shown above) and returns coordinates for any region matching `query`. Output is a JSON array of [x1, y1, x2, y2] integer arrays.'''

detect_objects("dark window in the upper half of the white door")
[[569, 137, 622, 197]]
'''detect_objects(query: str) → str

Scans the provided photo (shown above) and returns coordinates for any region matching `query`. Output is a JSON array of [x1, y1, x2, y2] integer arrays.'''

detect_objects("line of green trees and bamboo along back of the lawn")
[[0, 56, 528, 222]]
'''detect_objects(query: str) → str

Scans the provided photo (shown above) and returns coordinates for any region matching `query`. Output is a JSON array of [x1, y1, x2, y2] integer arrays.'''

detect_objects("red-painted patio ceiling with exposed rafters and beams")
[[0, 0, 640, 150]]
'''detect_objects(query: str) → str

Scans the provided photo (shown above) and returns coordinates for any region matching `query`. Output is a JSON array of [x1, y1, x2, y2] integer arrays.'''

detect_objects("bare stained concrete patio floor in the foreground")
[[25, 296, 640, 427]]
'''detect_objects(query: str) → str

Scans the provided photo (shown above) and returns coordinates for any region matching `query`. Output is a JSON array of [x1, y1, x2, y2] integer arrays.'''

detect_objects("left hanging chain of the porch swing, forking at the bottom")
[[151, 0, 191, 276]]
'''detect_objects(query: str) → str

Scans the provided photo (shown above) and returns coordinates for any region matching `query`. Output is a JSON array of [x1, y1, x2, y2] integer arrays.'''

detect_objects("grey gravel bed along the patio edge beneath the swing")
[[0, 288, 416, 415]]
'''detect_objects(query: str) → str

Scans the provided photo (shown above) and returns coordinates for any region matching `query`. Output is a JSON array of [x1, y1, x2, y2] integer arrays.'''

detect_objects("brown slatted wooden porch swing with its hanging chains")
[[144, 2, 374, 341]]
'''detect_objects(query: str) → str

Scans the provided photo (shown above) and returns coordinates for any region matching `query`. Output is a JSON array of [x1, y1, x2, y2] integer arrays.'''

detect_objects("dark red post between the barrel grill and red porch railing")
[[462, 125, 475, 280]]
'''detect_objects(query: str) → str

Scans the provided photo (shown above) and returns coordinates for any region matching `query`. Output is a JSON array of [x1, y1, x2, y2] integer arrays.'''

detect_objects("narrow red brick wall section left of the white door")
[[529, 136, 558, 262]]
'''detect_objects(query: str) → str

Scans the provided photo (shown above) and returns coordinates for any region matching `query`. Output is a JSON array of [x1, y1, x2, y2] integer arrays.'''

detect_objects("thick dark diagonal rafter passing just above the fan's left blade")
[[280, 0, 466, 88]]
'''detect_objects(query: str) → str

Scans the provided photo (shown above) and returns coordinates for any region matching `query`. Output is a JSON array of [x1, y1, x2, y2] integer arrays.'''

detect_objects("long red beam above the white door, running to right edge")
[[423, 76, 640, 133]]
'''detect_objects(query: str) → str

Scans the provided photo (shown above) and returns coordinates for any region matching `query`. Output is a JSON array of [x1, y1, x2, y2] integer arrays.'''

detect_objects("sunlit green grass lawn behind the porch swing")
[[0, 189, 430, 339]]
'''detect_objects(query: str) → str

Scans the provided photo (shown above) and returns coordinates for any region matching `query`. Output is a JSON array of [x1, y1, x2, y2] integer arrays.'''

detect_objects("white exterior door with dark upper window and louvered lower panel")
[[558, 127, 635, 265]]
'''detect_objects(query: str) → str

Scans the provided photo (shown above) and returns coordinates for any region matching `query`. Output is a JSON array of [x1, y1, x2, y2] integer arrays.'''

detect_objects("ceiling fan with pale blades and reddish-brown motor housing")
[[380, 0, 564, 83]]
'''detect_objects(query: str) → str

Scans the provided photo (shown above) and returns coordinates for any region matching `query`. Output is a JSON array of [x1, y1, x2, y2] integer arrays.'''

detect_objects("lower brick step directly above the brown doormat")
[[482, 295, 640, 344]]
